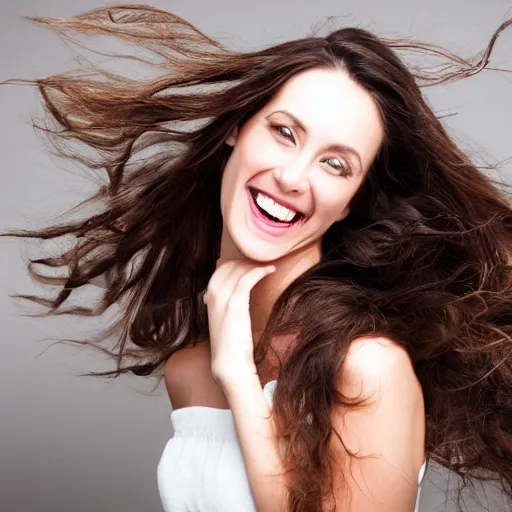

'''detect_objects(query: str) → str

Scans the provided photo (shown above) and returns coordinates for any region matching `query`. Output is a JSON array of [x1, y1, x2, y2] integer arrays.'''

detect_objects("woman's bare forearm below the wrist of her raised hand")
[[222, 373, 287, 512]]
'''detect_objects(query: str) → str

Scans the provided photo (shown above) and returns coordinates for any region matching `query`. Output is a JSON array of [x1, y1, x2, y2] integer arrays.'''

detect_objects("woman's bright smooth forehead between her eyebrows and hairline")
[[263, 69, 383, 168]]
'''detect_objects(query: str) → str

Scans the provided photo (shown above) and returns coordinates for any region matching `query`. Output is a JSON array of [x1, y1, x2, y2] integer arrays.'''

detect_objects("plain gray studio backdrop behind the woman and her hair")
[[0, 0, 512, 512]]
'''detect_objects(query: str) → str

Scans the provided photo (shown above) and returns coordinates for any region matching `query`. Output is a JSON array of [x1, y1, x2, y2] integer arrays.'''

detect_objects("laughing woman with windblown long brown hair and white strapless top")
[[4, 6, 512, 512]]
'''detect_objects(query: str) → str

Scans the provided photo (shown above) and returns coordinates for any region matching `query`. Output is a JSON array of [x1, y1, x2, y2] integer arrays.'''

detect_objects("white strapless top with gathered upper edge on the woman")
[[157, 380, 425, 512]]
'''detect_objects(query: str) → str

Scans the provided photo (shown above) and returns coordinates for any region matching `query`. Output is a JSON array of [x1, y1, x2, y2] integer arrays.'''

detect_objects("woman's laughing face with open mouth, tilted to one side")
[[221, 69, 383, 262]]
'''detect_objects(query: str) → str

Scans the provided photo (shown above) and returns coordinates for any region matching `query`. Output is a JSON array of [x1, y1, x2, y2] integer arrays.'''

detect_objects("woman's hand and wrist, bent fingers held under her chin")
[[203, 259, 275, 384]]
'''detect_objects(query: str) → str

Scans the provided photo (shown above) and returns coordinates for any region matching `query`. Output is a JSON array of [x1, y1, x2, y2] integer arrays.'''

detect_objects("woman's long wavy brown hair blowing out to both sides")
[[3, 5, 512, 512]]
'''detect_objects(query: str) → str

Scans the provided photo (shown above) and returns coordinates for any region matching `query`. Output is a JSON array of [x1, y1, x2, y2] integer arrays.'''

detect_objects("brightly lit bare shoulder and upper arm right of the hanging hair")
[[332, 337, 425, 510]]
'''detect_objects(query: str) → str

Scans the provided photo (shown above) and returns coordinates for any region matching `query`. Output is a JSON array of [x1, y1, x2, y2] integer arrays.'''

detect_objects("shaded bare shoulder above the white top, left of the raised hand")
[[164, 342, 228, 409]]
